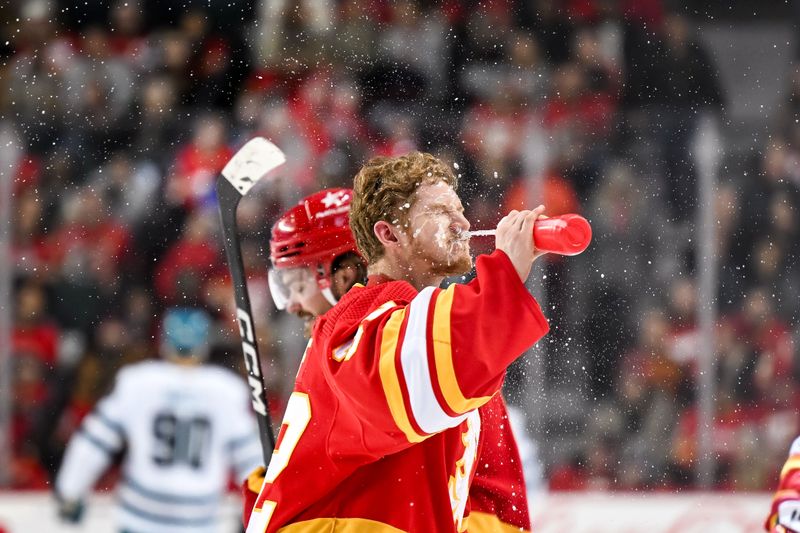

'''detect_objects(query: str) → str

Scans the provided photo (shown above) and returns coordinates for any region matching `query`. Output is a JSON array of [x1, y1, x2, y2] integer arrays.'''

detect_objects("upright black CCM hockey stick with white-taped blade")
[[217, 137, 286, 464]]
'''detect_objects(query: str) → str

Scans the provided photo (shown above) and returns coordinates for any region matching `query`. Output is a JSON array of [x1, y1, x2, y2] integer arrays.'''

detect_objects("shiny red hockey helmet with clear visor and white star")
[[269, 189, 358, 309]]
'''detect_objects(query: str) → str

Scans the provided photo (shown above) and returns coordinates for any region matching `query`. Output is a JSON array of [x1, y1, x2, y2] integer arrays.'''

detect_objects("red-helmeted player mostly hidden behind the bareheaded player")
[[243, 185, 530, 533]]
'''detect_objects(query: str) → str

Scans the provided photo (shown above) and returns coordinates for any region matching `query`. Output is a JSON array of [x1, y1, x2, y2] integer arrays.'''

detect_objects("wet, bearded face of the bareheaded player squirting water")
[[398, 182, 472, 276]]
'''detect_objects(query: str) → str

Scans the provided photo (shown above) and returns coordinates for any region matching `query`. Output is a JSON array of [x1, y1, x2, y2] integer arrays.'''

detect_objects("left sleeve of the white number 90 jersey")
[[55, 371, 126, 501]]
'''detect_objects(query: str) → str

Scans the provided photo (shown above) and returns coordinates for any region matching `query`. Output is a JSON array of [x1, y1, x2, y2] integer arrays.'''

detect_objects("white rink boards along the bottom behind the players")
[[0, 492, 770, 533]]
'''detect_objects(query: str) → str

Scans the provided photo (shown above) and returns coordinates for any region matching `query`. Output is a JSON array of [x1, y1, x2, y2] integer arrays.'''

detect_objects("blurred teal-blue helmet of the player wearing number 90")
[[161, 307, 211, 357]]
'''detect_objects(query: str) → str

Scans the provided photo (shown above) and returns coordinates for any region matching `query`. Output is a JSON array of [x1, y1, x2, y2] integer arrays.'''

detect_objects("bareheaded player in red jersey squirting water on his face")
[[247, 152, 548, 533]]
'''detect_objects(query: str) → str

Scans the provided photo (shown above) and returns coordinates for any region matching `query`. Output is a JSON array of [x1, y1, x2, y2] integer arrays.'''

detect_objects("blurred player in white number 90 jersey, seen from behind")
[[55, 308, 262, 533]]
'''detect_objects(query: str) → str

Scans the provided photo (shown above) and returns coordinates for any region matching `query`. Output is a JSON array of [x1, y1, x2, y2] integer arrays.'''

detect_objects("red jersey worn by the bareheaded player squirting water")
[[247, 251, 548, 533]]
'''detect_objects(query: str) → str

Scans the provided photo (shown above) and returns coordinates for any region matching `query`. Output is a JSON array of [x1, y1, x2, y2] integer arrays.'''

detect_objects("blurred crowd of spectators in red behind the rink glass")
[[0, 0, 800, 490]]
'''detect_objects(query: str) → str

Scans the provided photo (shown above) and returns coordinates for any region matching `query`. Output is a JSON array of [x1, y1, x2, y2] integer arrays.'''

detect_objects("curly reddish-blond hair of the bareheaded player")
[[350, 152, 458, 263]]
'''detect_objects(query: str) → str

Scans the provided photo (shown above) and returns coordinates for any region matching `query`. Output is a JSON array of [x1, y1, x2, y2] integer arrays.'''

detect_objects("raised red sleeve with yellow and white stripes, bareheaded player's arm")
[[328, 251, 548, 452]]
